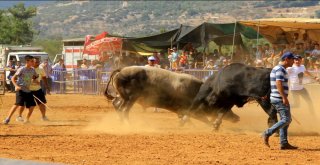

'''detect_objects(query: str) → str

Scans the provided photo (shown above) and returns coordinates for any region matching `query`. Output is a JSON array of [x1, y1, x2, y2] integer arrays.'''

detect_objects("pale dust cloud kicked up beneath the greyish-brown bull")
[[84, 105, 211, 134]]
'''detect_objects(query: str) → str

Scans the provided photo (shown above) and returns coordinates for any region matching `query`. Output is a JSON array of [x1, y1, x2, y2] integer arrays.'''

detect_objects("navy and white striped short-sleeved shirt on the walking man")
[[270, 65, 289, 101]]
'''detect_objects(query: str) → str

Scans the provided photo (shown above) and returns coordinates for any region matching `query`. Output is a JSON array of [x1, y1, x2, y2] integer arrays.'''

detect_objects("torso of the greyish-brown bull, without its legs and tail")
[[116, 66, 202, 109]]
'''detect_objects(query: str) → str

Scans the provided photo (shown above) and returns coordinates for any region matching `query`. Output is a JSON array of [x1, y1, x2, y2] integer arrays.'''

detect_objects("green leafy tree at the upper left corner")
[[0, 3, 36, 45]]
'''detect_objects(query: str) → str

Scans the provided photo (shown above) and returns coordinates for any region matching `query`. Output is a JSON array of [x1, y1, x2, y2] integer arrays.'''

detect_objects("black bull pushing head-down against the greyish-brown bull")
[[185, 63, 277, 129]]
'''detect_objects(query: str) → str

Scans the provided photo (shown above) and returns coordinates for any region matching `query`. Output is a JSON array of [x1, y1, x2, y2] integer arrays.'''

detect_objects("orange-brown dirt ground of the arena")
[[0, 85, 320, 165]]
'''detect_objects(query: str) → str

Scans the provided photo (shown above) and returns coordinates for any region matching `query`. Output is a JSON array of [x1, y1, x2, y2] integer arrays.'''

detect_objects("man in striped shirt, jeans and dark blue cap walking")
[[262, 52, 298, 150]]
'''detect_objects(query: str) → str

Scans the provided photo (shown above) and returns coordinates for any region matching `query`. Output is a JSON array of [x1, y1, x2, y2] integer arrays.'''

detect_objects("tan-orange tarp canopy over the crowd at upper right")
[[240, 18, 320, 43]]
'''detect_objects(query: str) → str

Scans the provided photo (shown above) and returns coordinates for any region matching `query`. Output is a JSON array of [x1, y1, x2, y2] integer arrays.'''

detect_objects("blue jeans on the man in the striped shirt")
[[265, 101, 292, 144]]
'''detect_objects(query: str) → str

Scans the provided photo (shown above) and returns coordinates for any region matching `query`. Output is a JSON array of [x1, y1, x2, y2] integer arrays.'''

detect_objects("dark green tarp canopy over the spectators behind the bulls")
[[124, 22, 261, 51]]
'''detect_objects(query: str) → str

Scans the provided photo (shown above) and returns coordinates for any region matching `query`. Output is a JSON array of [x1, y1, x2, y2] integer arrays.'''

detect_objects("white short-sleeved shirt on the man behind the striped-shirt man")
[[287, 65, 306, 90]]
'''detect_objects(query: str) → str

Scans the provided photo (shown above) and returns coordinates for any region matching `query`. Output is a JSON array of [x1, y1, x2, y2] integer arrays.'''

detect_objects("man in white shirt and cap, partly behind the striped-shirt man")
[[287, 55, 319, 113]]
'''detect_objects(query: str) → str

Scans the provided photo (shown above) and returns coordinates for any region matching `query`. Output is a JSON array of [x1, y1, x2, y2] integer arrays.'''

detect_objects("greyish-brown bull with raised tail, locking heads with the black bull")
[[105, 66, 239, 124]]
